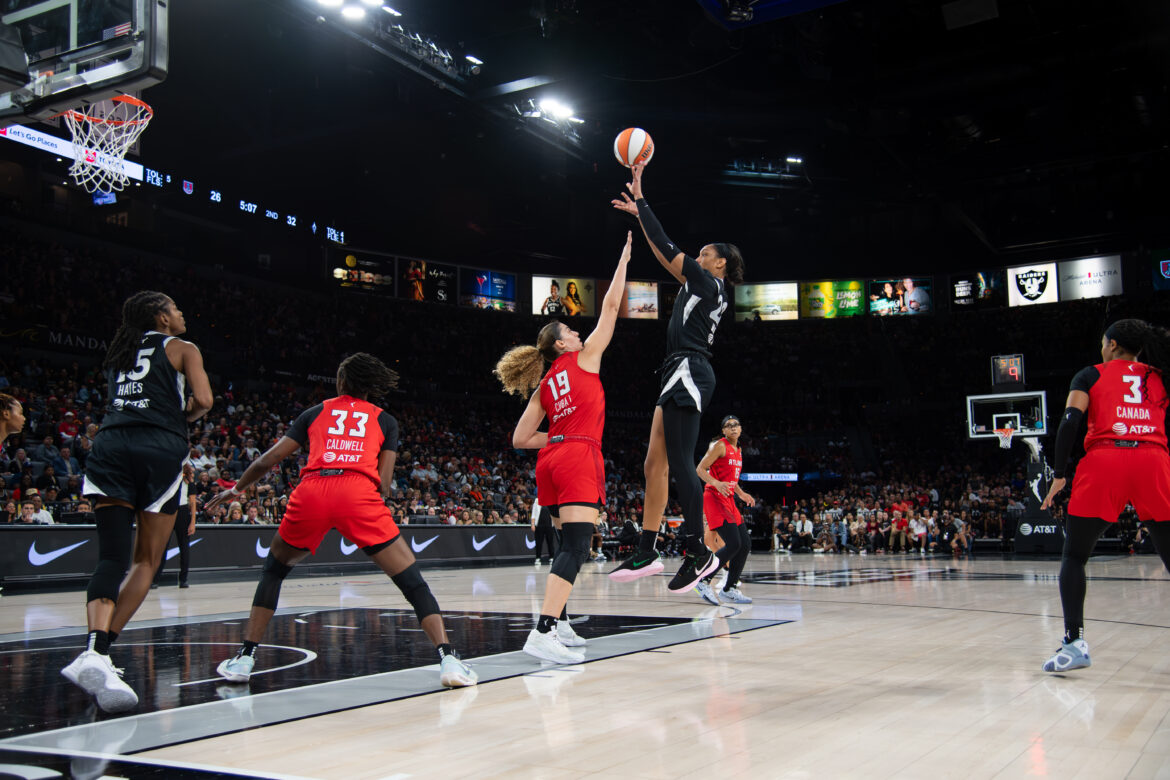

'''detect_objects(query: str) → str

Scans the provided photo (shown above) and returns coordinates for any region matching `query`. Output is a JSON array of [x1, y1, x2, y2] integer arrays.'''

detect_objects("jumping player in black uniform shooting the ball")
[[610, 164, 743, 593]]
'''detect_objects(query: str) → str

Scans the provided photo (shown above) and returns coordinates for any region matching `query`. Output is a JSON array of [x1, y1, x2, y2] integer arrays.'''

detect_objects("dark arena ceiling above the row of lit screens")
[[144, 0, 1170, 278]]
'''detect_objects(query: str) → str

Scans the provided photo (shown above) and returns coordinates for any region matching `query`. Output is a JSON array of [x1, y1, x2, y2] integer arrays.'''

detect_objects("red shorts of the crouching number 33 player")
[[277, 474, 398, 552]]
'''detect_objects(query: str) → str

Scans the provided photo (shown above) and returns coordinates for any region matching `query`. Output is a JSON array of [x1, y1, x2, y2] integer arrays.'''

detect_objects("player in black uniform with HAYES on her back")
[[61, 290, 212, 712]]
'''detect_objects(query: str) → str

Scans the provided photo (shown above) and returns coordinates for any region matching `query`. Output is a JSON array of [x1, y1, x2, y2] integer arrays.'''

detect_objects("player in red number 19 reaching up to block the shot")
[[495, 233, 633, 663]]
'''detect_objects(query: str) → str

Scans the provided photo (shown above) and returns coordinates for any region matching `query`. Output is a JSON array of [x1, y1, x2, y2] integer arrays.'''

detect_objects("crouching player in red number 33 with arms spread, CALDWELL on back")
[[207, 352, 477, 688]]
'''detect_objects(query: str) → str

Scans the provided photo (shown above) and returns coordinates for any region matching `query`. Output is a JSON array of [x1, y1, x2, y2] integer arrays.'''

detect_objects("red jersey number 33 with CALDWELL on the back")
[[285, 395, 398, 485]]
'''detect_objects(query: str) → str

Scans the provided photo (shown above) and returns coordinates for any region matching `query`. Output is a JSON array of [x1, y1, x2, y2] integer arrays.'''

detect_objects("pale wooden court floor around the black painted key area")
[[0, 554, 1170, 780]]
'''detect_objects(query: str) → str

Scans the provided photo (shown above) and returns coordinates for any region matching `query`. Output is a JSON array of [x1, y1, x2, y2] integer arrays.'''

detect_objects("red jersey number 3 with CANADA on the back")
[[1073, 360, 1166, 450]]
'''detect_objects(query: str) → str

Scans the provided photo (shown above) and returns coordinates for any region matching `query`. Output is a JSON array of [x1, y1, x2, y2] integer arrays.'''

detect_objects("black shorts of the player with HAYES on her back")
[[82, 426, 190, 515]]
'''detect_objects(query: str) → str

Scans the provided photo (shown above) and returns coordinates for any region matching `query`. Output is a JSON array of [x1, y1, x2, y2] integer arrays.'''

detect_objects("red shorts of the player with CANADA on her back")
[[1068, 444, 1170, 523]]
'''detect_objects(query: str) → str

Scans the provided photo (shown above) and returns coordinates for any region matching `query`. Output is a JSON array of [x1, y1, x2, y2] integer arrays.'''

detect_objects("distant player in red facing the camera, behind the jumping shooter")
[[695, 414, 756, 605]]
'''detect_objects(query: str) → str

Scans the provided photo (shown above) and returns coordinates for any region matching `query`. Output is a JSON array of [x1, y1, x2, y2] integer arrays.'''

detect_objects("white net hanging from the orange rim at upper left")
[[63, 95, 154, 193]]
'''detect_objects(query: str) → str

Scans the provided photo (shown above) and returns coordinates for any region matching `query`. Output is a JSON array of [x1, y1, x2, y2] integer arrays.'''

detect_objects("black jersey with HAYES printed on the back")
[[102, 331, 187, 439]]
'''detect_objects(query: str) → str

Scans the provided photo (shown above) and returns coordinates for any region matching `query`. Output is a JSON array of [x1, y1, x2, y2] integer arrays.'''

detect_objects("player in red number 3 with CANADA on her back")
[[1041, 319, 1170, 671]]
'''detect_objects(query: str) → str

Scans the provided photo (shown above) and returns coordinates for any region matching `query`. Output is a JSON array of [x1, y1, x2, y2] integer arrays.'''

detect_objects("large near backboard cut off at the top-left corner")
[[0, 0, 168, 127]]
